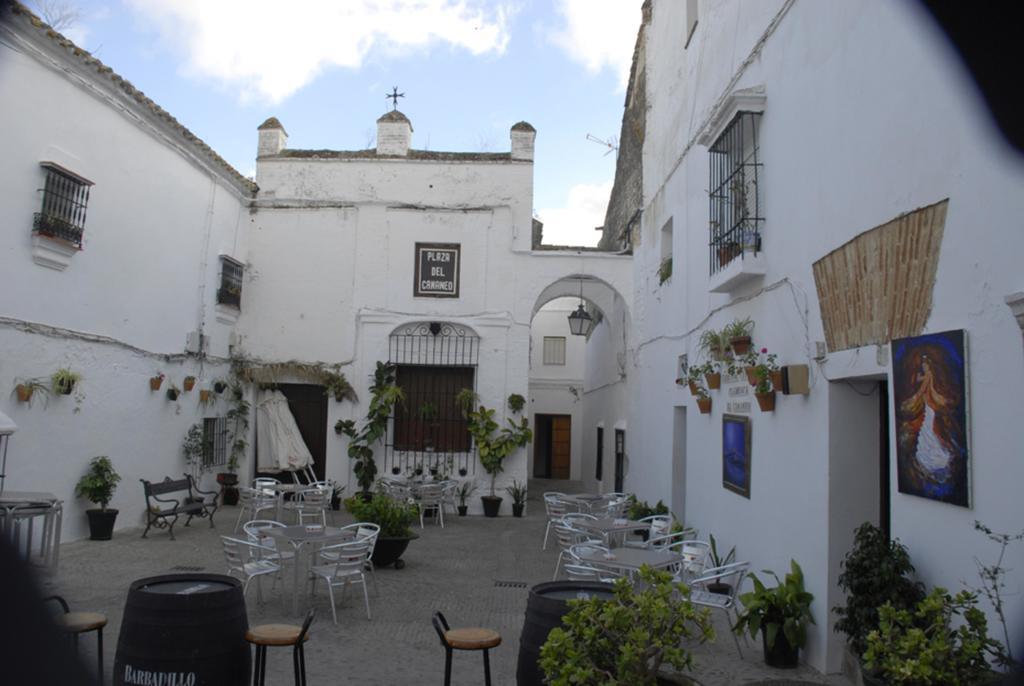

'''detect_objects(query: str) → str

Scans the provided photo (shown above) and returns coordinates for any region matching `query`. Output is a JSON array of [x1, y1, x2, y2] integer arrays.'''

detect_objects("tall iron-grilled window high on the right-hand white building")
[[709, 112, 764, 274]]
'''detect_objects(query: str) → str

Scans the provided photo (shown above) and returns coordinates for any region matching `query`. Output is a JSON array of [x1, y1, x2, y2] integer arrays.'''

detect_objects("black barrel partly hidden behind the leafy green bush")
[[515, 582, 615, 686]]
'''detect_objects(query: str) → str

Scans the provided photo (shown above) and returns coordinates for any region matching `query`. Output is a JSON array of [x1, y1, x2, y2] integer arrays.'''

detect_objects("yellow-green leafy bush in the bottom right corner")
[[863, 588, 1005, 686]]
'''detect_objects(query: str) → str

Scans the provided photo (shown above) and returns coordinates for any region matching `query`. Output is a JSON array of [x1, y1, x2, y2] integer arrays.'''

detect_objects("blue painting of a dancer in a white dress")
[[892, 330, 971, 508]]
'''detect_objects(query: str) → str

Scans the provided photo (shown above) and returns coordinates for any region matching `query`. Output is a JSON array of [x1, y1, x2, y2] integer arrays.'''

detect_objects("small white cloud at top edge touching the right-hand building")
[[551, 0, 642, 91]]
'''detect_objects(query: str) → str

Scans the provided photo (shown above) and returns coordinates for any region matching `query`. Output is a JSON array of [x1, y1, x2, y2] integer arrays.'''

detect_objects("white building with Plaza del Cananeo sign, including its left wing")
[[0, 5, 632, 539]]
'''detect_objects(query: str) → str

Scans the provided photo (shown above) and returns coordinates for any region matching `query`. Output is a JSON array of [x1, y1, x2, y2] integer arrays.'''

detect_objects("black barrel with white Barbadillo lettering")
[[114, 574, 252, 686]]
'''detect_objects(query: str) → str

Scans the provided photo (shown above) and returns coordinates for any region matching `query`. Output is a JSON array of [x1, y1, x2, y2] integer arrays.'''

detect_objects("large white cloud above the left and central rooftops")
[[127, 0, 510, 102]]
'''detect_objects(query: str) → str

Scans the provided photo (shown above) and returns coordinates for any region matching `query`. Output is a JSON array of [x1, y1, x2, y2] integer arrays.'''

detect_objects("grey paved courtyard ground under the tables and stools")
[[37, 481, 847, 686]]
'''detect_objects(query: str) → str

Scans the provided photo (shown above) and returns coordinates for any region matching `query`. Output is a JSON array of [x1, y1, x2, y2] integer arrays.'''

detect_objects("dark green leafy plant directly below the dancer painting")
[[833, 522, 925, 657]]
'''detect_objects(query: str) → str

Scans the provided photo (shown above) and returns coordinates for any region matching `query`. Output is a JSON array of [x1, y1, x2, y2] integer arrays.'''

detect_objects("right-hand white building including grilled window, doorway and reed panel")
[[587, 0, 1024, 672]]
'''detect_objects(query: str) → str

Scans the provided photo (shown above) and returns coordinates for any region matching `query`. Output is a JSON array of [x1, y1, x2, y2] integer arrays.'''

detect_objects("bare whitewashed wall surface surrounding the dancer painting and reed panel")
[[628, 0, 1024, 671]]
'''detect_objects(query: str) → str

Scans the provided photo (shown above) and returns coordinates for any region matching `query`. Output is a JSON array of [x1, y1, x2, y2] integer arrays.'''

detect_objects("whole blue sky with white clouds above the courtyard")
[[41, 0, 641, 245]]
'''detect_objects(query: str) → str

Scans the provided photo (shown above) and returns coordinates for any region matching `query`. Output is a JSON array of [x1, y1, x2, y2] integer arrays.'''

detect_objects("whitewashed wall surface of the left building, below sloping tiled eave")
[[0, 22, 248, 540]]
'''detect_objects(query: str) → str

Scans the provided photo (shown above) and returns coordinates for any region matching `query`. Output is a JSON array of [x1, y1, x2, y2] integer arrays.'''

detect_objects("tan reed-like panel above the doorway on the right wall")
[[814, 199, 949, 350]]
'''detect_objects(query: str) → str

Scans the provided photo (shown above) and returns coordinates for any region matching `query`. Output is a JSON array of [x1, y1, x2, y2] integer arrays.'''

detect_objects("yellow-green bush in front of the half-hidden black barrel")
[[541, 566, 715, 686]]
